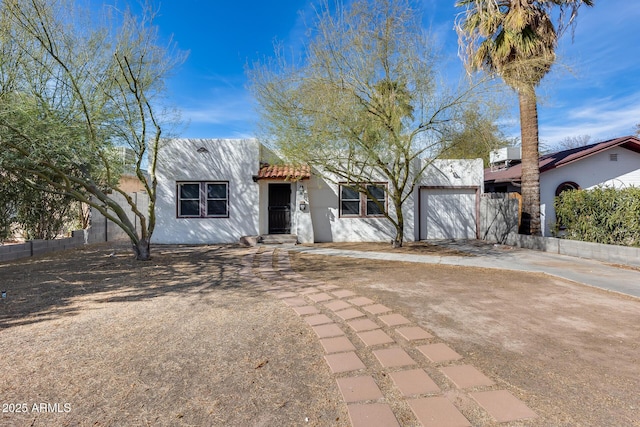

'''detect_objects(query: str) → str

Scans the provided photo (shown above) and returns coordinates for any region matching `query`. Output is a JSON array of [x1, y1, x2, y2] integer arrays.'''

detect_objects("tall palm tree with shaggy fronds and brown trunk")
[[456, 0, 594, 235]]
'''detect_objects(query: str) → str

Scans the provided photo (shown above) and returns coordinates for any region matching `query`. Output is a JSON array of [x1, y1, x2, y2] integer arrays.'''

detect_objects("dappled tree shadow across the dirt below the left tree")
[[0, 243, 262, 330]]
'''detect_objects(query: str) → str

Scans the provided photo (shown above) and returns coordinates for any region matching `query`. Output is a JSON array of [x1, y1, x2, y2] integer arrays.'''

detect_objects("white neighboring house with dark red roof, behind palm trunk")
[[484, 136, 640, 236]]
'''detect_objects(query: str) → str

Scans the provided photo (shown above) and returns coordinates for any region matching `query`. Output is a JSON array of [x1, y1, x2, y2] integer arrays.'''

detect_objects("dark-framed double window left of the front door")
[[178, 182, 229, 218]]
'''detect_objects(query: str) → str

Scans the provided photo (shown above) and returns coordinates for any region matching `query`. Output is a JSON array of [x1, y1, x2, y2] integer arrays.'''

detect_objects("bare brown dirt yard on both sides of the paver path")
[[0, 245, 640, 426]]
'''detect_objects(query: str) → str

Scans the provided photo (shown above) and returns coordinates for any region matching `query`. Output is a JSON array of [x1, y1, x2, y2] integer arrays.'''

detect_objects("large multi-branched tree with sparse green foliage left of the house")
[[0, 0, 184, 260]]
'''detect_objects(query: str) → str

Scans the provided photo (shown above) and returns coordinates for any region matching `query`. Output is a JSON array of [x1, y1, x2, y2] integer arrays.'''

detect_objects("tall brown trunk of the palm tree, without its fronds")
[[518, 87, 541, 236]]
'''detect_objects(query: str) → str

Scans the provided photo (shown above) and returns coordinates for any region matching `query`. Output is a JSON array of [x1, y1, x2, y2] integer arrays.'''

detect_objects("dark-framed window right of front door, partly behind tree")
[[340, 183, 387, 218]]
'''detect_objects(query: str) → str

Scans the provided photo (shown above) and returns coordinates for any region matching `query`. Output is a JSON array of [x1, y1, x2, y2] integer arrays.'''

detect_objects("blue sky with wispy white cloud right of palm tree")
[[514, 0, 640, 145]]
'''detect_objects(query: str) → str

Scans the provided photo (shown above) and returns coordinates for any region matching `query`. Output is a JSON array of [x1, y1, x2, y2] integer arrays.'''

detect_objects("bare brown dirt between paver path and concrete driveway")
[[292, 244, 640, 426]]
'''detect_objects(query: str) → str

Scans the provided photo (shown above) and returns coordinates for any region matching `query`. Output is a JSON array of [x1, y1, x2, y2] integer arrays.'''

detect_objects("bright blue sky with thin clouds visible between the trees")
[[151, 0, 640, 150]]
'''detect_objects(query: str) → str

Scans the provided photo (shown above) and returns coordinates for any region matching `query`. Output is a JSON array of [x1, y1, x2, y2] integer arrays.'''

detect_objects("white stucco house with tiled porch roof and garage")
[[153, 139, 483, 244]]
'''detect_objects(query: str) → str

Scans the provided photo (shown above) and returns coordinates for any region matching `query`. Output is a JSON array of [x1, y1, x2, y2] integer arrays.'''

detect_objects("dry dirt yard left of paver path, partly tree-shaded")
[[0, 246, 346, 426]]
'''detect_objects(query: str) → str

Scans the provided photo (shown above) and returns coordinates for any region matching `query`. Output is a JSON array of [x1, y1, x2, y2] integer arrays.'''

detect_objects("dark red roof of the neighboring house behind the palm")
[[484, 136, 640, 182]]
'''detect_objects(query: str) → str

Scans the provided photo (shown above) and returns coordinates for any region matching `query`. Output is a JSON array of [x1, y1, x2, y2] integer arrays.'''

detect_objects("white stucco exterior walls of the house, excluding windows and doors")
[[152, 139, 483, 244]]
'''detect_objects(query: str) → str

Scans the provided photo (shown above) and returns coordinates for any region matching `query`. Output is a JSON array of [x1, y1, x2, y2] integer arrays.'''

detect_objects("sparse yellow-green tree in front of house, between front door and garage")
[[249, 0, 478, 247]]
